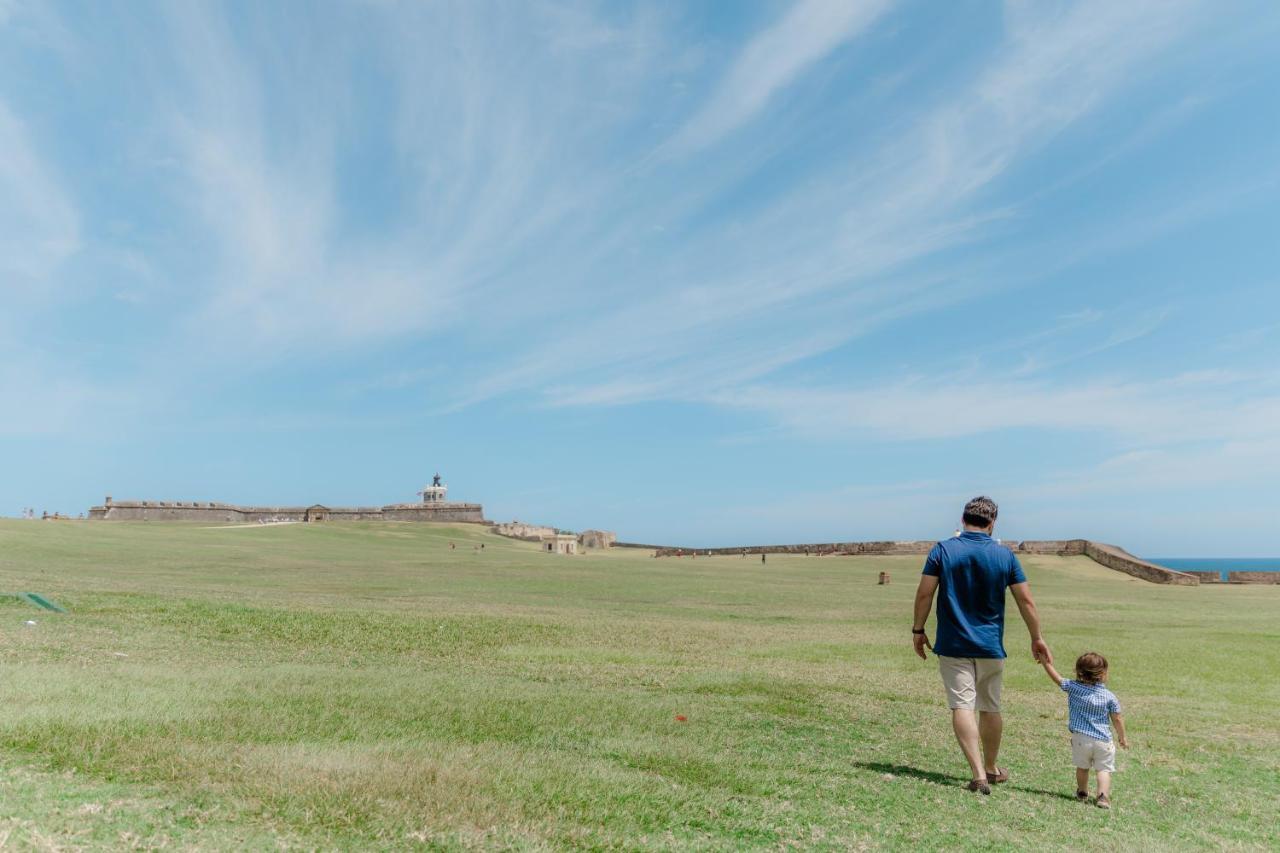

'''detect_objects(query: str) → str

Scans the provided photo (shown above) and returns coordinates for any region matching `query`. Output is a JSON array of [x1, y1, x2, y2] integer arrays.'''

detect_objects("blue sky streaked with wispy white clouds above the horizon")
[[0, 0, 1280, 556]]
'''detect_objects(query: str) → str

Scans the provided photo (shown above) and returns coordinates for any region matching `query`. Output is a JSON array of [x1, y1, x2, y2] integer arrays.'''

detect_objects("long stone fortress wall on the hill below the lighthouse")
[[88, 498, 485, 524]]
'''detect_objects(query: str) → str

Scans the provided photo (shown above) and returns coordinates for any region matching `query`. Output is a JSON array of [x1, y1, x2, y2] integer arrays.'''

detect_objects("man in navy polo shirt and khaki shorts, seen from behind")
[[911, 497, 1053, 794]]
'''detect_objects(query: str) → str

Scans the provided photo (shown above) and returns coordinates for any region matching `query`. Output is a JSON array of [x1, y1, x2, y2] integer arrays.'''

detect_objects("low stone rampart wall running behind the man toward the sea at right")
[[654, 539, 1203, 587]]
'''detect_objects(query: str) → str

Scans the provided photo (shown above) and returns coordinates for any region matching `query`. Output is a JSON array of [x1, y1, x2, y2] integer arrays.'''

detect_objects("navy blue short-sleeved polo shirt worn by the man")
[[924, 530, 1027, 657]]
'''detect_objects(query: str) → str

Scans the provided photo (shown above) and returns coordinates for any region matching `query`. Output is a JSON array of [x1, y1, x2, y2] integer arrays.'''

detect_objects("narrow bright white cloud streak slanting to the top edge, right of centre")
[[672, 0, 892, 154]]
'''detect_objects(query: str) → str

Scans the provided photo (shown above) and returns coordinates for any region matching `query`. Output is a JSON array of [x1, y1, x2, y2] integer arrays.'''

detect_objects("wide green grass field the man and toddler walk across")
[[0, 521, 1280, 849]]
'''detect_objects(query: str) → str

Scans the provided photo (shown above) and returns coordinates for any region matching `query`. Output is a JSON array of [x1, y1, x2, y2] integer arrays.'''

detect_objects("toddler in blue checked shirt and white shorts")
[[1042, 652, 1129, 808]]
